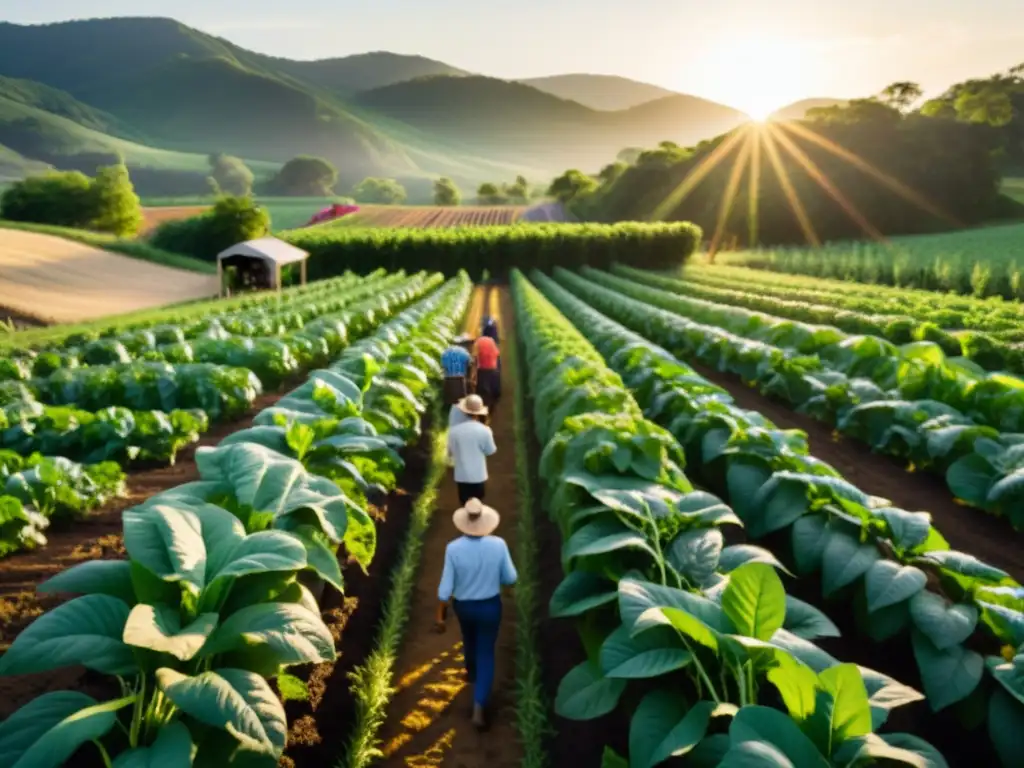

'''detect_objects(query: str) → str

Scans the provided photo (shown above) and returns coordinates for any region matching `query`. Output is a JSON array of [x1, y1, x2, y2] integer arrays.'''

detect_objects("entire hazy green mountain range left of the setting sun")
[[0, 17, 761, 196]]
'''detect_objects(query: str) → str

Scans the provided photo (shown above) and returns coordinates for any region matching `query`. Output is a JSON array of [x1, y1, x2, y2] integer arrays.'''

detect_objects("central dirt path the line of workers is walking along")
[[381, 288, 521, 768]]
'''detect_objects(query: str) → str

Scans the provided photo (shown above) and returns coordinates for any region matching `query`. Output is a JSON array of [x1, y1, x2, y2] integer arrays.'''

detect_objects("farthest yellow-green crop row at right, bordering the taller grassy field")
[[671, 264, 1024, 341]]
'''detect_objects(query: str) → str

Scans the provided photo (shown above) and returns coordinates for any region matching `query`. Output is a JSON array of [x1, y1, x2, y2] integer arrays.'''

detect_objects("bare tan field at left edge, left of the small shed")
[[0, 229, 217, 323]]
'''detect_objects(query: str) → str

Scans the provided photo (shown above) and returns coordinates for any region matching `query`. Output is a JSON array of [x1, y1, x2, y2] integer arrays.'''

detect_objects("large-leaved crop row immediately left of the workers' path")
[[0, 276, 470, 768]]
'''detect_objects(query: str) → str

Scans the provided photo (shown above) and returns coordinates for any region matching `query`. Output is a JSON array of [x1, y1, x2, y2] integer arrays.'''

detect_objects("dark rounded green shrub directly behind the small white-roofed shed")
[[151, 196, 270, 261]]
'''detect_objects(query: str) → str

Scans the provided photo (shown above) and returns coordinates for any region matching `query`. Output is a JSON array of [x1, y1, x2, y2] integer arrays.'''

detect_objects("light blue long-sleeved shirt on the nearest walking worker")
[[437, 536, 517, 602]]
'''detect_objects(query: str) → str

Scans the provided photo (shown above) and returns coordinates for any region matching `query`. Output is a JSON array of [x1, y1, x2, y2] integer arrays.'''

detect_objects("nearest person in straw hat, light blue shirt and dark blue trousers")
[[436, 499, 517, 730]]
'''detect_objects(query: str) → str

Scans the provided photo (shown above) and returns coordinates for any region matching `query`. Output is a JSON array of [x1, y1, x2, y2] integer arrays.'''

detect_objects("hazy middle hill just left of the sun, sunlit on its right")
[[354, 76, 749, 170]]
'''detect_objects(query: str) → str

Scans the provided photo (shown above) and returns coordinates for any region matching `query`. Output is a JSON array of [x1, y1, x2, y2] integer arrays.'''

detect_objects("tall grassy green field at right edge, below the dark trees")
[[716, 224, 1024, 299]]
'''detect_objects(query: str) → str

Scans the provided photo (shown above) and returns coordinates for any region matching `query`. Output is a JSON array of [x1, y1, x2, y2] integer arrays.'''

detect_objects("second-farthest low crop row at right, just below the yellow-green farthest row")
[[613, 266, 1024, 373]]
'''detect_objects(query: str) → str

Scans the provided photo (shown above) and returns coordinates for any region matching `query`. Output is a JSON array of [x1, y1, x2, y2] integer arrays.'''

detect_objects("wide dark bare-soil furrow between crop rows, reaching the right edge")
[[688, 361, 1024, 582]]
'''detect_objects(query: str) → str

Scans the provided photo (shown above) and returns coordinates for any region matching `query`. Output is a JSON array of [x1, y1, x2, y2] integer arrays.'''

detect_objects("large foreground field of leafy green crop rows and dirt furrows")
[[0, 250, 1024, 768]]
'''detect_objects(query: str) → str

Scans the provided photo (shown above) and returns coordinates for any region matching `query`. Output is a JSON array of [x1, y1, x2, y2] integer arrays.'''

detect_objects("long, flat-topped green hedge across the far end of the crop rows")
[[281, 222, 701, 280]]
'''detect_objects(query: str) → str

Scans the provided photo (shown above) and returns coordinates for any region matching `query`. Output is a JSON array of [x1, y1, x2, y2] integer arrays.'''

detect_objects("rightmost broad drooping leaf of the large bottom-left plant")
[[203, 602, 336, 666]]
